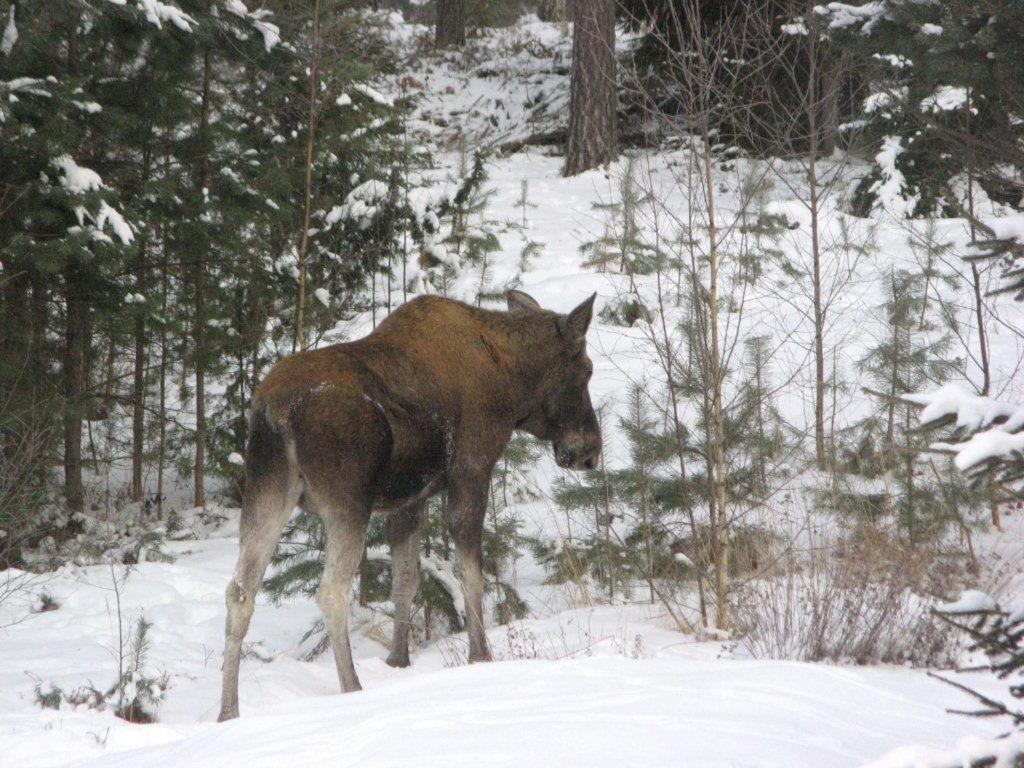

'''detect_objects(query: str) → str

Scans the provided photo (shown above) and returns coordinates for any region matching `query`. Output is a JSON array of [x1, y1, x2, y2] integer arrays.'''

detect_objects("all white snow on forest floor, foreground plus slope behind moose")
[[0, 10, 1022, 768]]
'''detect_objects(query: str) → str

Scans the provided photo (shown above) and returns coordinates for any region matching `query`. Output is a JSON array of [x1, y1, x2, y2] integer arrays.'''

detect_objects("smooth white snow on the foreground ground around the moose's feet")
[[0, 511, 1011, 768]]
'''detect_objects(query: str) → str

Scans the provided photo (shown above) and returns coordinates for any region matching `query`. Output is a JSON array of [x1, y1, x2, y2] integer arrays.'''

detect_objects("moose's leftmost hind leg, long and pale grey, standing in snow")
[[217, 477, 299, 721]]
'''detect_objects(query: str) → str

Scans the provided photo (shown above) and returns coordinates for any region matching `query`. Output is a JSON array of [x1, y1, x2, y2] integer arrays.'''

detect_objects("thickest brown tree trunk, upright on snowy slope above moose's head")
[[562, 0, 618, 176]]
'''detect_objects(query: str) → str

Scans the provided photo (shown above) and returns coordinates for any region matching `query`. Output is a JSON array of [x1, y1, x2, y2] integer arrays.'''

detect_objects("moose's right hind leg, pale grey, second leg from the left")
[[316, 511, 369, 693]]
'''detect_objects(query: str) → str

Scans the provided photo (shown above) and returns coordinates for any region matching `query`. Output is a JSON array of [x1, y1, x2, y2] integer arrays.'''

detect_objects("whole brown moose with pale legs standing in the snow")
[[219, 291, 601, 720]]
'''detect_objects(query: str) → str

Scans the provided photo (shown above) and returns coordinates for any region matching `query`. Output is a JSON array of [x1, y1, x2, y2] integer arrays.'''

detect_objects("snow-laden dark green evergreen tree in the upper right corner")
[[820, 0, 1024, 215]]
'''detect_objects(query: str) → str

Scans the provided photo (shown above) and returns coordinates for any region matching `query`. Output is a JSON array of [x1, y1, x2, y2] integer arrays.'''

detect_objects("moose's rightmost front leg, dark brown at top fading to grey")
[[449, 474, 490, 664]]
